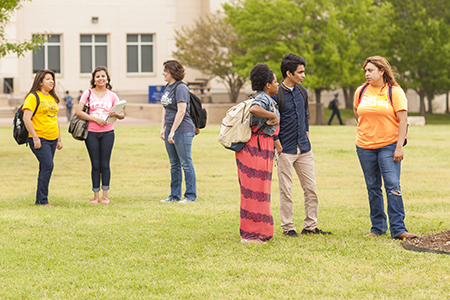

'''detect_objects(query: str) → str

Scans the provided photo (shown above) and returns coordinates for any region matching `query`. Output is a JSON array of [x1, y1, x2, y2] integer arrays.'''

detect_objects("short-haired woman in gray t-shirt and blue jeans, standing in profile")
[[159, 60, 197, 203]]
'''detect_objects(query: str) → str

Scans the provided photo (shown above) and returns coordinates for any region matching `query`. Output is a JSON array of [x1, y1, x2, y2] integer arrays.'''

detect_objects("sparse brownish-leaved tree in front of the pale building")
[[174, 14, 247, 103]]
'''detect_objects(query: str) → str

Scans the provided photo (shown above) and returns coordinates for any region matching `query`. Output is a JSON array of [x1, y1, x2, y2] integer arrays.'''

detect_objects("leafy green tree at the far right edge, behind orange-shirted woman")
[[388, 0, 450, 116]]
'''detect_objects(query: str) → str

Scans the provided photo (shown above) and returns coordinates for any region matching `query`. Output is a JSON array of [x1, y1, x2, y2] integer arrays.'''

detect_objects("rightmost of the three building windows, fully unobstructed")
[[127, 34, 153, 73]]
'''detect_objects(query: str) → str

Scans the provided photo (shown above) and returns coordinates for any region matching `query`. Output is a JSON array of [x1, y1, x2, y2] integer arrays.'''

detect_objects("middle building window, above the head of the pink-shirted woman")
[[80, 34, 108, 73]]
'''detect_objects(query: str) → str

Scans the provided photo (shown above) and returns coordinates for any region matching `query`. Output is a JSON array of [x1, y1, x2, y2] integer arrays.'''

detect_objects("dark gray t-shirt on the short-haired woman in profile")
[[161, 81, 195, 132]]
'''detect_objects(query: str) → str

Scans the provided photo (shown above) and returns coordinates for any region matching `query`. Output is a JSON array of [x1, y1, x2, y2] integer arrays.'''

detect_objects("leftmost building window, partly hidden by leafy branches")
[[33, 34, 61, 74]]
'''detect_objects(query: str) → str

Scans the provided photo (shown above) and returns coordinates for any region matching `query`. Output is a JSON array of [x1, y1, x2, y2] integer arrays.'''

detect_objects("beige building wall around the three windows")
[[0, 0, 229, 101]]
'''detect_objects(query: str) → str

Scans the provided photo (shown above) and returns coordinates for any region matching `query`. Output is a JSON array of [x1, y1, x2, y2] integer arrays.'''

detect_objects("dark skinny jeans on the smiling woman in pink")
[[85, 130, 114, 192]]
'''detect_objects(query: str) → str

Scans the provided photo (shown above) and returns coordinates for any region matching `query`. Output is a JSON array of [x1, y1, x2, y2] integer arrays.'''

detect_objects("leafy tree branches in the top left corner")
[[0, 0, 45, 58]]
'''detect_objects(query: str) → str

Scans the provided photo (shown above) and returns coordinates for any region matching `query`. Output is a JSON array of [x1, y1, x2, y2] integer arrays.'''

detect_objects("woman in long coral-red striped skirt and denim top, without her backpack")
[[236, 64, 281, 244]]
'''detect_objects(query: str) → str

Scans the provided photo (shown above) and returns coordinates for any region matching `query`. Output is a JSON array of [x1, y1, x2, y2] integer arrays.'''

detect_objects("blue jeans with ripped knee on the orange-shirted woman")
[[356, 143, 408, 237]]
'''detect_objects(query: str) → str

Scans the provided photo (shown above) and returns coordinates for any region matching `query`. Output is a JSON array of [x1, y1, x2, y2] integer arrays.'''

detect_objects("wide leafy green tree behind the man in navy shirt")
[[224, 0, 390, 124]]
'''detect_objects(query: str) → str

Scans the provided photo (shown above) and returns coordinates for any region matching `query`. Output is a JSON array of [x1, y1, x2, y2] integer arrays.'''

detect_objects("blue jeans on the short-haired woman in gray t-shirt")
[[165, 130, 197, 201]]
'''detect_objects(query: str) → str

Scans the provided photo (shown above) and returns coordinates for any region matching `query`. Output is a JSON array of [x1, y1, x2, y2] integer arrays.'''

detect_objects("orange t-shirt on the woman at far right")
[[353, 83, 408, 149]]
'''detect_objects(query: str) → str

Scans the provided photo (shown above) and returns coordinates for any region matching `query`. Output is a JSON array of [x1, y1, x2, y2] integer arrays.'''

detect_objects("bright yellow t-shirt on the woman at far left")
[[22, 91, 59, 140]]
